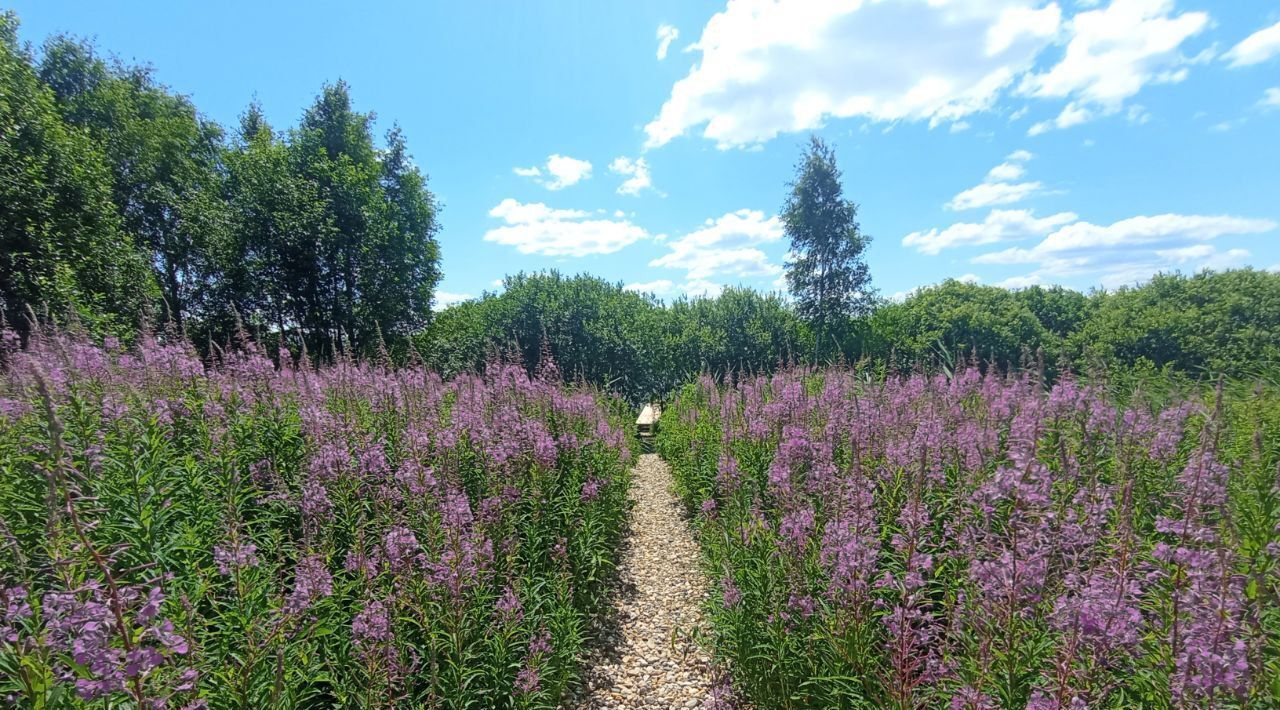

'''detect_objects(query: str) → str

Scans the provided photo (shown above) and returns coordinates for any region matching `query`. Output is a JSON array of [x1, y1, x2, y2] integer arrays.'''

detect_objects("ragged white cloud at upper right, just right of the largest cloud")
[[1019, 0, 1210, 136]]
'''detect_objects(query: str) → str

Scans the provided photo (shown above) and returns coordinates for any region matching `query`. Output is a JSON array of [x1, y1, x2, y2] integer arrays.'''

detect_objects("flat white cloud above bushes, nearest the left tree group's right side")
[[484, 197, 649, 257]]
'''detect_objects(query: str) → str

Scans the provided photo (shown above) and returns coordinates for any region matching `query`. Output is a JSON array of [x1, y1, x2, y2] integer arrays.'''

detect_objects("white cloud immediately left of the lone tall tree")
[[649, 210, 782, 281]]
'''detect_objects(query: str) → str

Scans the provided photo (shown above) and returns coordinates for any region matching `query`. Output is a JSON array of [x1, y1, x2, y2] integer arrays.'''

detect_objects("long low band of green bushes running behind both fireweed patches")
[[412, 269, 1280, 400]]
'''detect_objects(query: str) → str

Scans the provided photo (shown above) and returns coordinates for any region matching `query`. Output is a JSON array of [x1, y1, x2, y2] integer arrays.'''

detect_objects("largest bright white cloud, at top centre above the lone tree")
[[645, 0, 1061, 147]]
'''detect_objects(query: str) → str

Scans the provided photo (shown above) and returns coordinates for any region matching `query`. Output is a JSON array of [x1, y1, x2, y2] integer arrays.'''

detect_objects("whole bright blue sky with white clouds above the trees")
[[9, 0, 1280, 302]]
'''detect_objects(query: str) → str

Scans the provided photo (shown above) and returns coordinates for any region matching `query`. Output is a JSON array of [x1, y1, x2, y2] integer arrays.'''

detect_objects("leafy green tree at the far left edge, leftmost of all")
[[0, 13, 155, 331]]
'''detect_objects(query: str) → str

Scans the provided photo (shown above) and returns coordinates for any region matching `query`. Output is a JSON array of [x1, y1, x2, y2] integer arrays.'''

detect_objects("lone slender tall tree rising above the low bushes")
[[781, 136, 874, 358]]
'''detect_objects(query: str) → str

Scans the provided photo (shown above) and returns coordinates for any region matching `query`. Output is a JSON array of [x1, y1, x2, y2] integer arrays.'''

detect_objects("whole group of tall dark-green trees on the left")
[[0, 13, 440, 353]]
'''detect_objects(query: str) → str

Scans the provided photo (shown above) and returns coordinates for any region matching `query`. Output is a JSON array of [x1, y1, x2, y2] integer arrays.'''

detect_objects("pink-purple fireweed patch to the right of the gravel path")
[[658, 368, 1280, 709]]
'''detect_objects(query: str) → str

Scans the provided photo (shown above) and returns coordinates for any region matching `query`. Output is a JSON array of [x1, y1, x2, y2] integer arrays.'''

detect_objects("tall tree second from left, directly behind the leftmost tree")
[[40, 36, 225, 324]]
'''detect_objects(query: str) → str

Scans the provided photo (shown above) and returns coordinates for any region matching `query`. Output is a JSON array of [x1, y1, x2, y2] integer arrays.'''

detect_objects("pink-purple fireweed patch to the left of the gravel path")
[[0, 333, 631, 707]]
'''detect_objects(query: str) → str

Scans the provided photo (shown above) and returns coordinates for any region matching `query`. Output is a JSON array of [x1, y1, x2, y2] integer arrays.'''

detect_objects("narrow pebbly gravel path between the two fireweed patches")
[[566, 454, 712, 709]]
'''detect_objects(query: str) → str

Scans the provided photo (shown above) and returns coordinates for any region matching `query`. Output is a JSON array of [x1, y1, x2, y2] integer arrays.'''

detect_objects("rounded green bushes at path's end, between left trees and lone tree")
[[416, 271, 812, 402]]
